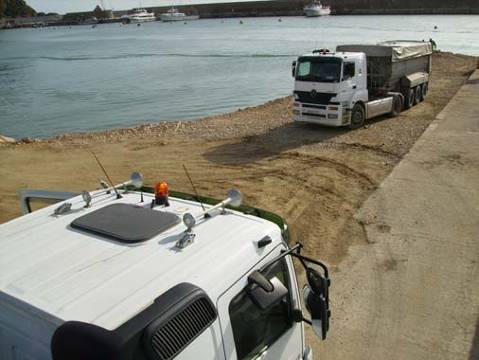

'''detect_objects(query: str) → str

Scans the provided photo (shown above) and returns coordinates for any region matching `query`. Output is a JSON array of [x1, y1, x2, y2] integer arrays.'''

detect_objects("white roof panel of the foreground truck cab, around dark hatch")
[[0, 191, 282, 330]]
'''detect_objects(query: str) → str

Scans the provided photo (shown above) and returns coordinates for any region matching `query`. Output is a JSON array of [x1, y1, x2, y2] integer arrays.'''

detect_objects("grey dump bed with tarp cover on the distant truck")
[[336, 41, 432, 92]]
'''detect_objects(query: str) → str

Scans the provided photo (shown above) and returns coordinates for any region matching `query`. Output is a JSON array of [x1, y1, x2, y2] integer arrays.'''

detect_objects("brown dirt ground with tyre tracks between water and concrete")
[[0, 53, 477, 353]]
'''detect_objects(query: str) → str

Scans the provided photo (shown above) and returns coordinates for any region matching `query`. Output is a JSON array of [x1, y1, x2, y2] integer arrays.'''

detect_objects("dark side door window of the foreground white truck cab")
[[229, 260, 293, 360]]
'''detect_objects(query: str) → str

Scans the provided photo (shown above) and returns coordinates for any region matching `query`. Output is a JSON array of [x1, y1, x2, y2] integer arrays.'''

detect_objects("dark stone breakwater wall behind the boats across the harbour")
[[0, 0, 479, 29]]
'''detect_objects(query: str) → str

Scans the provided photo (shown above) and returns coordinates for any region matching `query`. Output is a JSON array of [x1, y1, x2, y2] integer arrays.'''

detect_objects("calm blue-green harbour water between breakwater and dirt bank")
[[0, 16, 479, 138]]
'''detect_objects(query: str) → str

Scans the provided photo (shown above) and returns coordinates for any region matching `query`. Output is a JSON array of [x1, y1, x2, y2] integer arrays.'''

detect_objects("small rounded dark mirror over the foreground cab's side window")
[[246, 270, 288, 310]]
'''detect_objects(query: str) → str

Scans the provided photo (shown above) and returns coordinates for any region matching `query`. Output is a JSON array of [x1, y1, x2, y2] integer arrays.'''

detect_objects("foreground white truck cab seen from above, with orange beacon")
[[0, 173, 330, 360]]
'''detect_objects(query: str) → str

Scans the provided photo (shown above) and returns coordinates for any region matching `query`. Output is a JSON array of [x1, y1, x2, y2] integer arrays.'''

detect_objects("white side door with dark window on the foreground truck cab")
[[218, 245, 304, 360]]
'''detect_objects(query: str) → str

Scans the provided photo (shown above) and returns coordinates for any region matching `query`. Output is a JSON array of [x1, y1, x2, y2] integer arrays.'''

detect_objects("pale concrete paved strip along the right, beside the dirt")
[[315, 70, 479, 360]]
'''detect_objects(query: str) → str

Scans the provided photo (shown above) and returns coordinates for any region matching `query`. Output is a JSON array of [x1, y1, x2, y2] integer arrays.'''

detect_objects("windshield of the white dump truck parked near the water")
[[296, 57, 342, 83]]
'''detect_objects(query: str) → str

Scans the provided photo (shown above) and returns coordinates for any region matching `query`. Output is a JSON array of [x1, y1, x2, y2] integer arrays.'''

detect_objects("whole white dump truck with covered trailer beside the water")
[[293, 41, 432, 129]]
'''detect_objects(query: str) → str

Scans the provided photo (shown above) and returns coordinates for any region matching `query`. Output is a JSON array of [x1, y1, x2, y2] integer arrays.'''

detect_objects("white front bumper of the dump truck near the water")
[[293, 102, 351, 126]]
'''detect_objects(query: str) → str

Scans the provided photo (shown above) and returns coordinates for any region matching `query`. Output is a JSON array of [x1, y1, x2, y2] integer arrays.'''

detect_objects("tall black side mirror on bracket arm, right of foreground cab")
[[303, 267, 331, 340]]
